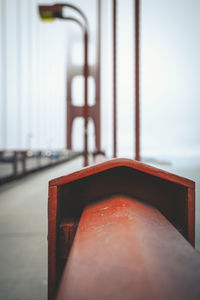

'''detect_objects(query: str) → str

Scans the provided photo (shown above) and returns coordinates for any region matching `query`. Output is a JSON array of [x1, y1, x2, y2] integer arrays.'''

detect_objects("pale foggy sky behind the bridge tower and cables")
[[0, 0, 200, 161]]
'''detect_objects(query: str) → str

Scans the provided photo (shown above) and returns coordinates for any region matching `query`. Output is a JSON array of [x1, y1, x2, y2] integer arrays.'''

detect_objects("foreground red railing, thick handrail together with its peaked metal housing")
[[48, 158, 200, 299]]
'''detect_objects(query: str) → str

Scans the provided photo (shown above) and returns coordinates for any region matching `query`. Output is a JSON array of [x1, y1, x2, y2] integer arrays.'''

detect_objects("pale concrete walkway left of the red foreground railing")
[[0, 158, 83, 300]]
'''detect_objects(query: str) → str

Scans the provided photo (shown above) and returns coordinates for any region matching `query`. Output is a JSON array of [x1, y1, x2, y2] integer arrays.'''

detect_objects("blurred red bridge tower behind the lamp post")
[[66, 0, 101, 150]]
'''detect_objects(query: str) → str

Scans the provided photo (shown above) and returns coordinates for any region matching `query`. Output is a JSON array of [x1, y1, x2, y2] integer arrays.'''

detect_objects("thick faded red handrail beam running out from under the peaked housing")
[[57, 195, 200, 300]]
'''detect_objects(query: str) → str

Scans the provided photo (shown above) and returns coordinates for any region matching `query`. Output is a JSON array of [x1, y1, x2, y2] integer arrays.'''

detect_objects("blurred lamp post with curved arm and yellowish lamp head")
[[39, 3, 88, 166]]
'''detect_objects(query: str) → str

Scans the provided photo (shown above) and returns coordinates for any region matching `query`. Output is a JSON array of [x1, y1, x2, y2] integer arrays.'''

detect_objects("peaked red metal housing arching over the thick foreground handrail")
[[48, 159, 195, 299]]
